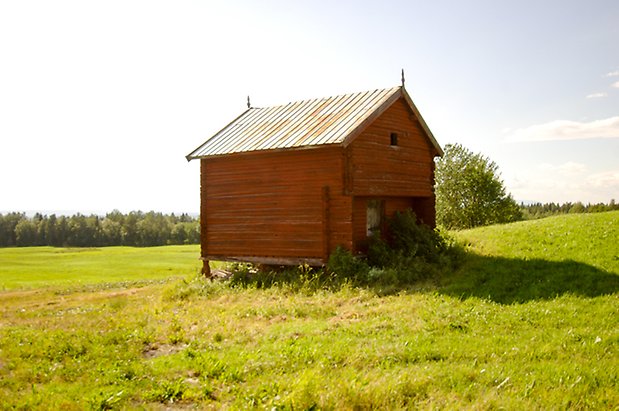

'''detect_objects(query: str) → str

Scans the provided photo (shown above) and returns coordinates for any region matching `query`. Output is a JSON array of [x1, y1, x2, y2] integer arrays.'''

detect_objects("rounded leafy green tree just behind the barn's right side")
[[436, 144, 522, 229]]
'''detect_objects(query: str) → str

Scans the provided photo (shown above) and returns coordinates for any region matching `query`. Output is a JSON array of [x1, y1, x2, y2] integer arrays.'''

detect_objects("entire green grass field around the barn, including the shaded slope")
[[0, 212, 619, 410]]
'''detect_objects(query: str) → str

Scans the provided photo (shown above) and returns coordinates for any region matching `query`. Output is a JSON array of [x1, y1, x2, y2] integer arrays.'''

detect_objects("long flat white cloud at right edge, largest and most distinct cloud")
[[506, 115, 619, 142]]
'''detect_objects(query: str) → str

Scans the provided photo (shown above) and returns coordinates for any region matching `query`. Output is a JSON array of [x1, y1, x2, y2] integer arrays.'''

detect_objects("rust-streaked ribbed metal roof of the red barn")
[[187, 87, 442, 161]]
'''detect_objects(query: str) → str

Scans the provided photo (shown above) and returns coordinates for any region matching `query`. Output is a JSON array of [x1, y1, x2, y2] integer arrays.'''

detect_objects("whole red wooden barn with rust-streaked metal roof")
[[187, 86, 442, 275]]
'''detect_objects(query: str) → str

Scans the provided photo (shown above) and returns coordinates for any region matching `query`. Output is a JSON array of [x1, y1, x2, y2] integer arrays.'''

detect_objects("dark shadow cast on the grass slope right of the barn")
[[439, 254, 619, 304]]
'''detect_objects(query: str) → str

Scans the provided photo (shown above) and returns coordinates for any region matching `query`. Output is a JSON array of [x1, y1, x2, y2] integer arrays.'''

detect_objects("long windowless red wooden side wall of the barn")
[[201, 146, 352, 263]]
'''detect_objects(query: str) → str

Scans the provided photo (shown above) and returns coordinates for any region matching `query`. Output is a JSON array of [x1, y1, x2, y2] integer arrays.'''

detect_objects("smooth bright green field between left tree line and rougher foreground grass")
[[0, 245, 201, 290]]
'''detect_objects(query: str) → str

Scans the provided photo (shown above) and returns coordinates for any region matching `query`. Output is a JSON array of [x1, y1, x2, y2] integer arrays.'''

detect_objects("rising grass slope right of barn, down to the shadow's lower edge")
[[441, 211, 619, 303]]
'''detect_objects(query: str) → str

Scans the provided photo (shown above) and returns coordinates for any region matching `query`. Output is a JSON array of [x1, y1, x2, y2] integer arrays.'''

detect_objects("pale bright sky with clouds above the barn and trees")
[[0, 0, 619, 212]]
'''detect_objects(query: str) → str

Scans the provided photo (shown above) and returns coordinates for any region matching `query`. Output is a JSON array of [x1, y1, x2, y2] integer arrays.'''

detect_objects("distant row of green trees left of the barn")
[[0, 210, 200, 247]]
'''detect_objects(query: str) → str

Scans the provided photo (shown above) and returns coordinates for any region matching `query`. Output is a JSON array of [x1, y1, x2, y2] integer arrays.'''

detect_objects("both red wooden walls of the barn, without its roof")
[[200, 93, 439, 270]]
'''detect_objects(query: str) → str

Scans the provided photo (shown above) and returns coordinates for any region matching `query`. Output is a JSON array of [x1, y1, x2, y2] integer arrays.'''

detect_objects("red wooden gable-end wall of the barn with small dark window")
[[345, 99, 436, 253]]
